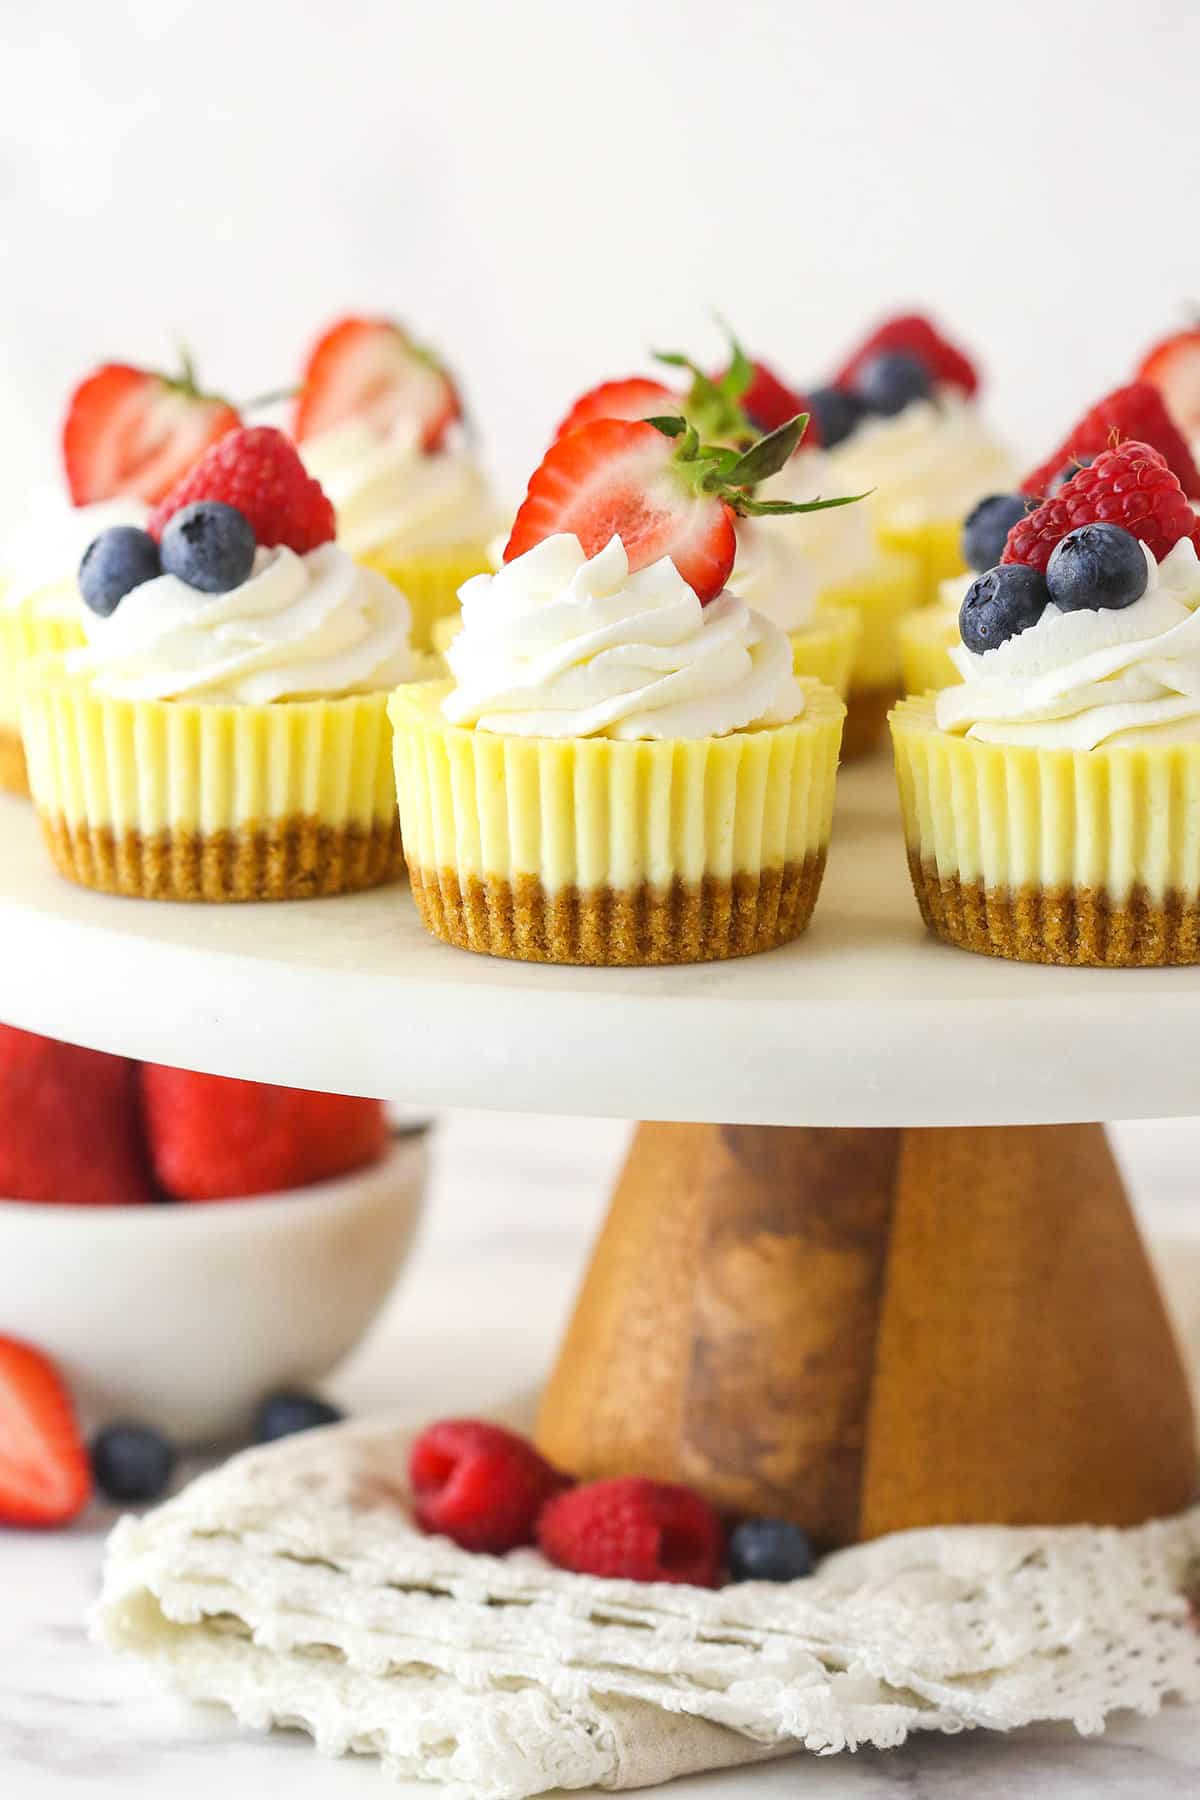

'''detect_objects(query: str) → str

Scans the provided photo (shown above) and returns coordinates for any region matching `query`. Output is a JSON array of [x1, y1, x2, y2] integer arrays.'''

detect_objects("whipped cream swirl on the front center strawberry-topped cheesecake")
[[443, 533, 804, 740]]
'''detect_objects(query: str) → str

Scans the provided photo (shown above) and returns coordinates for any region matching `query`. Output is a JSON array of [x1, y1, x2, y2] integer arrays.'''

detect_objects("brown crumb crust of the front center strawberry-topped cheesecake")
[[408, 850, 826, 968]]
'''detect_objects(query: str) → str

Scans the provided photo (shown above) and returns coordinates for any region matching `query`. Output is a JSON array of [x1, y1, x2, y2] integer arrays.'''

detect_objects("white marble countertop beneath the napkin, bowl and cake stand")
[[0, 1114, 1200, 1800]]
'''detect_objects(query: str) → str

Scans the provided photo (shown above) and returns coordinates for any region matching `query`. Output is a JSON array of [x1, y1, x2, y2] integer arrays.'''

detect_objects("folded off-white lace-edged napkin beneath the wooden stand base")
[[97, 1422, 1200, 1800]]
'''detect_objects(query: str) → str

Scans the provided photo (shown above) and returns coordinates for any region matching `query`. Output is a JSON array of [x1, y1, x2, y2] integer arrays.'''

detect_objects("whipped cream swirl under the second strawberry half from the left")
[[299, 419, 497, 560]]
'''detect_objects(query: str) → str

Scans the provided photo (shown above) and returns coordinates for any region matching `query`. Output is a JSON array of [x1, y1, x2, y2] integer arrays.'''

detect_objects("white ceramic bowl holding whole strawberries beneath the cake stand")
[[0, 1136, 426, 1445]]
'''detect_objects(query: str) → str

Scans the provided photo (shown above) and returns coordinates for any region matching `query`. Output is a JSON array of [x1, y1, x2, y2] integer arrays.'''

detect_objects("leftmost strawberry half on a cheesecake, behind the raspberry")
[[63, 362, 241, 506]]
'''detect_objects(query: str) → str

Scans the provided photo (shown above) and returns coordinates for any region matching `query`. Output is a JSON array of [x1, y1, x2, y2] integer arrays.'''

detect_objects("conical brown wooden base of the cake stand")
[[538, 1125, 1196, 1546]]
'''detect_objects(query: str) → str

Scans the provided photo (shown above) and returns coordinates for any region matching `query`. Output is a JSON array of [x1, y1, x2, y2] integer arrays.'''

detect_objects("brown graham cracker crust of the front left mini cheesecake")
[[41, 814, 405, 900]]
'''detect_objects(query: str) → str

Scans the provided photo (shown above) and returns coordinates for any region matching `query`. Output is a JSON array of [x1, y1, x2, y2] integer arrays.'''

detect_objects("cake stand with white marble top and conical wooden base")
[[0, 765, 1200, 1544]]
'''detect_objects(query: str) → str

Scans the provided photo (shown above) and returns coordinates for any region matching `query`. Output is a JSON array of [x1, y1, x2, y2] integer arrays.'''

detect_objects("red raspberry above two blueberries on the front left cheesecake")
[[149, 425, 335, 556]]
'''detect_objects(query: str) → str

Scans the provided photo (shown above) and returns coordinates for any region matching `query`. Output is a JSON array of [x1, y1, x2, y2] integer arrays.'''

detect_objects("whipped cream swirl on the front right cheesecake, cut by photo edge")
[[937, 538, 1200, 751]]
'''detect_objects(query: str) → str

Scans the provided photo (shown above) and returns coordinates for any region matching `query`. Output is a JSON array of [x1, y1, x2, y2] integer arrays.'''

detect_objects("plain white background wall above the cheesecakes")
[[0, 0, 1200, 513]]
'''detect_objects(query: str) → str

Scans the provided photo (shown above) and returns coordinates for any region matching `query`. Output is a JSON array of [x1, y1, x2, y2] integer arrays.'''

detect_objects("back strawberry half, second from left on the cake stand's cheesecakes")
[[295, 319, 462, 450]]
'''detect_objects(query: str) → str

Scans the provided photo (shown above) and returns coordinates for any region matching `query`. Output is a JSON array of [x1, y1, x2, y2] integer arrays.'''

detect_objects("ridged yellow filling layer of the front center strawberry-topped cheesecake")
[[390, 680, 846, 893]]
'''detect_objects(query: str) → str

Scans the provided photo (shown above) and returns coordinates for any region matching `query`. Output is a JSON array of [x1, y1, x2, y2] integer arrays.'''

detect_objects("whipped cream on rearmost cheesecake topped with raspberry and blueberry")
[[829, 387, 1015, 527]]
